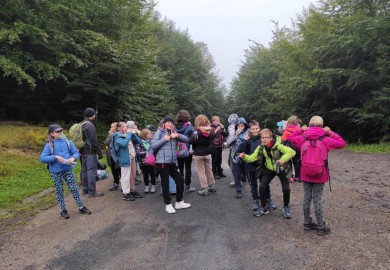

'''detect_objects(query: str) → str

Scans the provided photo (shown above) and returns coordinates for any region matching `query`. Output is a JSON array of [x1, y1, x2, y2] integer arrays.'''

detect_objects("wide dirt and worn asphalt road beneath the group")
[[0, 151, 390, 269]]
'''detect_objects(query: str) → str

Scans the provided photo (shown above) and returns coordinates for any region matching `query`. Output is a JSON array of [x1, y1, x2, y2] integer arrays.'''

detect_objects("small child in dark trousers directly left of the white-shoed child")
[[135, 128, 156, 193]]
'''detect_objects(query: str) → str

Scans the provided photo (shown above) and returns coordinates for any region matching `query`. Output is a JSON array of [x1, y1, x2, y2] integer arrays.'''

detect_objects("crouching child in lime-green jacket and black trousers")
[[240, 128, 295, 219]]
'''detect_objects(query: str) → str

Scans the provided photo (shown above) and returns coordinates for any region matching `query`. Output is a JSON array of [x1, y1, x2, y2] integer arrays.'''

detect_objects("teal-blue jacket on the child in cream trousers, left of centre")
[[114, 132, 139, 167]]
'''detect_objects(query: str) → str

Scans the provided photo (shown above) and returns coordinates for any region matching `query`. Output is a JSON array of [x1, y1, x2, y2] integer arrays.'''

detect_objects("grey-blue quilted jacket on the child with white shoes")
[[151, 129, 188, 164]]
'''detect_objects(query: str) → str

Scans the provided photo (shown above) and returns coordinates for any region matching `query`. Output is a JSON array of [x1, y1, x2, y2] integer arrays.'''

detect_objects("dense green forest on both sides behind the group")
[[0, 0, 390, 143]]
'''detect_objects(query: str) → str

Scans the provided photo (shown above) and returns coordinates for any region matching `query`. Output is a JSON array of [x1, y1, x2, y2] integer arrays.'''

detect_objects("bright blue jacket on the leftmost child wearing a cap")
[[39, 138, 80, 173]]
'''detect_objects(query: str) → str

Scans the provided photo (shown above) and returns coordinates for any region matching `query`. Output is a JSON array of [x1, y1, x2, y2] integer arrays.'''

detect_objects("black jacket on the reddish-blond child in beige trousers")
[[189, 128, 213, 156]]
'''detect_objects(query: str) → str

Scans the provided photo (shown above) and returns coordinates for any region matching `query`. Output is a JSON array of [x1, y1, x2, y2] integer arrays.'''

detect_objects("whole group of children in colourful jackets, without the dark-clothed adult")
[[40, 110, 346, 235]]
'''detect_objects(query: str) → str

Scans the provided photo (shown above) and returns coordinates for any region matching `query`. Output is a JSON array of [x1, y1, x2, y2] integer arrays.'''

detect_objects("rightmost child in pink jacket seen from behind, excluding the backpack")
[[288, 116, 346, 235]]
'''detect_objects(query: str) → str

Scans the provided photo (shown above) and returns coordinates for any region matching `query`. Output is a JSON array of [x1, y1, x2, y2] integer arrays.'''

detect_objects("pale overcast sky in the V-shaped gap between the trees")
[[155, 0, 316, 88]]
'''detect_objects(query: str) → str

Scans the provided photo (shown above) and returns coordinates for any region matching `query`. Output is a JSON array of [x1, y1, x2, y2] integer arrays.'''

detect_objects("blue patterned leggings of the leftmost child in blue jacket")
[[50, 170, 84, 211]]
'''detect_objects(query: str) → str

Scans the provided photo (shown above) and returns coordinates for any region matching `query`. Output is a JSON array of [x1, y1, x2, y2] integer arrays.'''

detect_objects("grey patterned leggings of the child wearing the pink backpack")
[[303, 181, 324, 225]]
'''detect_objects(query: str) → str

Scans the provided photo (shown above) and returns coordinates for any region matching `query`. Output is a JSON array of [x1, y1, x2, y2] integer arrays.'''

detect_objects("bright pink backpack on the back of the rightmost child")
[[301, 134, 328, 178]]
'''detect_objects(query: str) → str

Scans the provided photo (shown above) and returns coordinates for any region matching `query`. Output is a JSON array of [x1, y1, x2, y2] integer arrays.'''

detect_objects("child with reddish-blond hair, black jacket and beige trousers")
[[189, 114, 217, 196]]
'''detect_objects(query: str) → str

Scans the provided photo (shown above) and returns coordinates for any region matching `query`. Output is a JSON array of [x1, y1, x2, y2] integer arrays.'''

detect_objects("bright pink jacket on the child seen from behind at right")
[[288, 127, 347, 183]]
